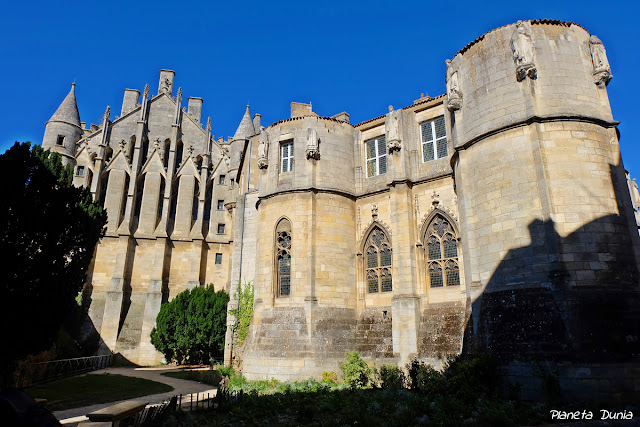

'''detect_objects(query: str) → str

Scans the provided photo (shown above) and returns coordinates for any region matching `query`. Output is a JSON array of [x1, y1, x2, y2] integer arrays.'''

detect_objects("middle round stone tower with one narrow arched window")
[[243, 110, 357, 379]]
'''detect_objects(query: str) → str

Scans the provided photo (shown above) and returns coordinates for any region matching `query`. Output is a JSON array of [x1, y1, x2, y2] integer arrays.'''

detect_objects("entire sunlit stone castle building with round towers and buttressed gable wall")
[[43, 20, 640, 388]]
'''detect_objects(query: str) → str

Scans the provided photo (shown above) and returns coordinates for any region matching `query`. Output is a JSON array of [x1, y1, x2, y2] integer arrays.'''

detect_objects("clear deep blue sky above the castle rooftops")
[[0, 0, 640, 180]]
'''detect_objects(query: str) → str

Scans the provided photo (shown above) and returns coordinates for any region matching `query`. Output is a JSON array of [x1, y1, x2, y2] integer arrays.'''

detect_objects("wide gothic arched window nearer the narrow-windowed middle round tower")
[[364, 227, 393, 293]]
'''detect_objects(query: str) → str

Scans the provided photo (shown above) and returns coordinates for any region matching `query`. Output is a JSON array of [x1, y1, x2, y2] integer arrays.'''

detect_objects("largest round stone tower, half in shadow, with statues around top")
[[447, 20, 640, 359]]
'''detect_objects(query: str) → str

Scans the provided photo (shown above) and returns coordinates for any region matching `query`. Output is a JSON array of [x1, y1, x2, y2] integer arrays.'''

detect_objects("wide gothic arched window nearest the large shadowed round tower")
[[425, 214, 460, 288]]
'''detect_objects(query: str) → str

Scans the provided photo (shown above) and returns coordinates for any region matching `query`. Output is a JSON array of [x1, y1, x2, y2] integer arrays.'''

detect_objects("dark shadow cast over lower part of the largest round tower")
[[464, 162, 640, 402]]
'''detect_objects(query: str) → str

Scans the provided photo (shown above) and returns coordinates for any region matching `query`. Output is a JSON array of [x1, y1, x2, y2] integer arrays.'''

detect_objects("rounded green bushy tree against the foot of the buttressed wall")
[[151, 285, 229, 364]]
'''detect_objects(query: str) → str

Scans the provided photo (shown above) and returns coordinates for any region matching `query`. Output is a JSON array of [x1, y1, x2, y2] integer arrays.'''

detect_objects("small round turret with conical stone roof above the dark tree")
[[42, 83, 83, 166]]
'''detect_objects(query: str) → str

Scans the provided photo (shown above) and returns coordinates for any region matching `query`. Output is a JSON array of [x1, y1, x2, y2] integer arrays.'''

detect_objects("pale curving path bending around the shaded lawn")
[[53, 366, 216, 426]]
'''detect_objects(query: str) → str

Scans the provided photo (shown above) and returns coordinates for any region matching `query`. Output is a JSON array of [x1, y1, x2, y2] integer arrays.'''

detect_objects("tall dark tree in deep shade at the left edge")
[[0, 143, 106, 383]]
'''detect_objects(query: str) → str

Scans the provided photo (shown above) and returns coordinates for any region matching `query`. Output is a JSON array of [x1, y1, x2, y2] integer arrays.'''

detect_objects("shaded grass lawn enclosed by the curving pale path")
[[25, 374, 173, 411]]
